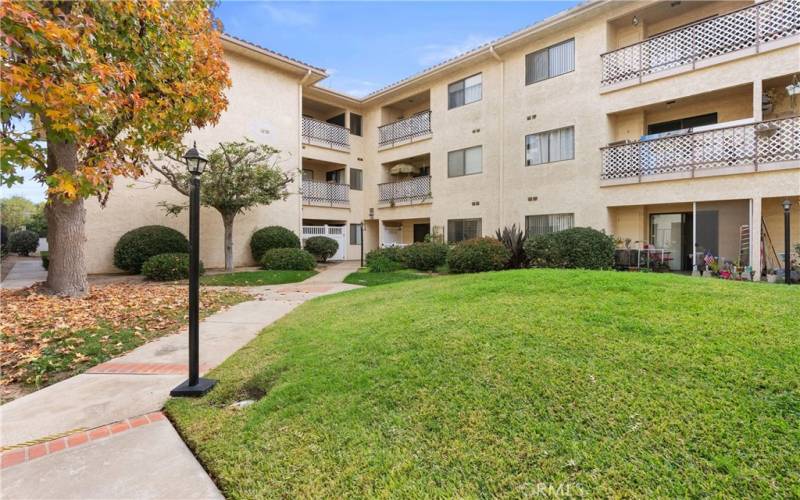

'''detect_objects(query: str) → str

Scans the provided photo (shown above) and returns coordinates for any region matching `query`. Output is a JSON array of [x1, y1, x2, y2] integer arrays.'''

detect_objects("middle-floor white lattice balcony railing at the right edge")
[[601, 116, 800, 185]]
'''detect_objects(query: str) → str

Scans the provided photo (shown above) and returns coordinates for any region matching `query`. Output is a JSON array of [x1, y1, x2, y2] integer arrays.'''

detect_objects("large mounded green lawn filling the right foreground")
[[167, 270, 800, 498]]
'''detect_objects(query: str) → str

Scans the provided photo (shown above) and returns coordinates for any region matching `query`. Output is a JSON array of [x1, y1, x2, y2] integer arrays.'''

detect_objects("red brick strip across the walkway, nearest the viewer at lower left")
[[0, 411, 167, 469]]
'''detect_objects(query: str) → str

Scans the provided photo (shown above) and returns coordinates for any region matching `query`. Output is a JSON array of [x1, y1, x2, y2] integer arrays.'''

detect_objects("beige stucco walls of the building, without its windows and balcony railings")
[[84, 2, 800, 272]]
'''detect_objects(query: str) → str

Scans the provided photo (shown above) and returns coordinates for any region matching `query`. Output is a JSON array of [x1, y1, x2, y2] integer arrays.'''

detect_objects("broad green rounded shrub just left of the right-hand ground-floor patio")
[[525, 227, 616, 269]]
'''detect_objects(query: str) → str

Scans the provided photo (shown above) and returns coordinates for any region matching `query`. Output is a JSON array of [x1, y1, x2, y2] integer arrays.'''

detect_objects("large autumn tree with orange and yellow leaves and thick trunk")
[[0, 0, 230, 296]]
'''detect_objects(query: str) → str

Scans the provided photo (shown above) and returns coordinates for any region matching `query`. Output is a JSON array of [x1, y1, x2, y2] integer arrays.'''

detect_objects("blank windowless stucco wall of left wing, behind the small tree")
[[86, 52, 300, 273]]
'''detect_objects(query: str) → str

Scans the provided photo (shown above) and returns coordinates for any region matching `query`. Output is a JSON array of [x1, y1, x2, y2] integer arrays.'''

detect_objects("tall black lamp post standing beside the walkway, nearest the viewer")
[[169, 143, 217, 397]]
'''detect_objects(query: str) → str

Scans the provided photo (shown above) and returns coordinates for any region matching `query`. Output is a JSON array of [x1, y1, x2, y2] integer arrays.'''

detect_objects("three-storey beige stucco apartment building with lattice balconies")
[[87, 0, 800, 282]]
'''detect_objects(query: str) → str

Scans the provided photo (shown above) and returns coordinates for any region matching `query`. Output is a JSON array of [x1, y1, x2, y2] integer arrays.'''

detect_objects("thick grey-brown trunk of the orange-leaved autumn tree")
[[45, 140, 89, 297]]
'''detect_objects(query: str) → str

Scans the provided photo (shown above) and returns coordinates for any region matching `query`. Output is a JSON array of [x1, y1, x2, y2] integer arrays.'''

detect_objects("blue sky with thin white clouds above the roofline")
[[0, 1, 578, 202]]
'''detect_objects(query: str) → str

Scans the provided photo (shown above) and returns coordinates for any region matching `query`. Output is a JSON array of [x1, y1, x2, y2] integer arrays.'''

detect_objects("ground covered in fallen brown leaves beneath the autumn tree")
[[0, 284, 249, 386]]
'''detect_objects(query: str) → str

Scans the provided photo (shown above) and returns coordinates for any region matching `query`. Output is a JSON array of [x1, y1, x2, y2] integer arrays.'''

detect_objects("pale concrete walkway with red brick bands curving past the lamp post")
[[0, 261, 358, 498]]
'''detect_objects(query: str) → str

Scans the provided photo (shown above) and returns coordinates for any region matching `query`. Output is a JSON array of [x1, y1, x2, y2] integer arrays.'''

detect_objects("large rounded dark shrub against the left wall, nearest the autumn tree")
[[114, 226, 189, 274]]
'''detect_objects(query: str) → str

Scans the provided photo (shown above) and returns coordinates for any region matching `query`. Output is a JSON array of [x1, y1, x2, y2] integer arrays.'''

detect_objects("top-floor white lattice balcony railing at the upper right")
[[601, 0, 800, 87]]
